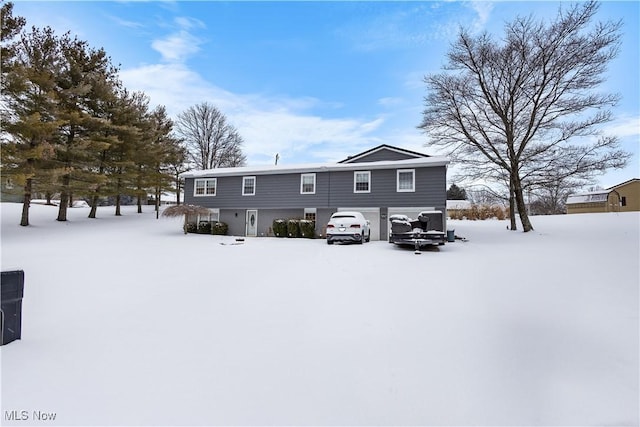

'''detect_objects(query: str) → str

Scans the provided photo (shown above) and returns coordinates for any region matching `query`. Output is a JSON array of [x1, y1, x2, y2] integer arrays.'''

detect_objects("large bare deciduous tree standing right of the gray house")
[[419, 1, 629, 232]]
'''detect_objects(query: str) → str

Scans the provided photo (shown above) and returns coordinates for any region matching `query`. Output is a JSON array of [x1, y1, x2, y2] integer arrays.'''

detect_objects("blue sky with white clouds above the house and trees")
[[14, 1, 640, 187]]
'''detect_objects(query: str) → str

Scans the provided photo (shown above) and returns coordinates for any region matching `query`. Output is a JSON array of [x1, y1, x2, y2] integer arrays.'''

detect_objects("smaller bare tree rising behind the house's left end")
[[175, 102, 246, 169]]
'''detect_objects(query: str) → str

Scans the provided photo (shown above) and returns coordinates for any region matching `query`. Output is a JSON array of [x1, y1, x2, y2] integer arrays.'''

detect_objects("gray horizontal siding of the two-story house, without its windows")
[[184, 149, 447, 238]]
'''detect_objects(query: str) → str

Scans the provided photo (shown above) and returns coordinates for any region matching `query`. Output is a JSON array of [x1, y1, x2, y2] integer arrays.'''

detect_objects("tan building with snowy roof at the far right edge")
[[566, 178, 640, 214]]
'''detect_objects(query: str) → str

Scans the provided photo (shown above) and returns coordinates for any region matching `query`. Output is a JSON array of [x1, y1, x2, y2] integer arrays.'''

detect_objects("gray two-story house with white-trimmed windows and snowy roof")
[[183, 145, 449, 240]]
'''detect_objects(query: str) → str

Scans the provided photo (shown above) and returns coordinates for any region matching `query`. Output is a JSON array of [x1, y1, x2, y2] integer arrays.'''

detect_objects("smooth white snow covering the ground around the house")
[[0, 203, 640, 426]]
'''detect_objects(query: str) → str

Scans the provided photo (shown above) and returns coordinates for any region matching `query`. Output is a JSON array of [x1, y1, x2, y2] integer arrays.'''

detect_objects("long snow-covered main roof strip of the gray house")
[[181, 156, 449, 178]]
